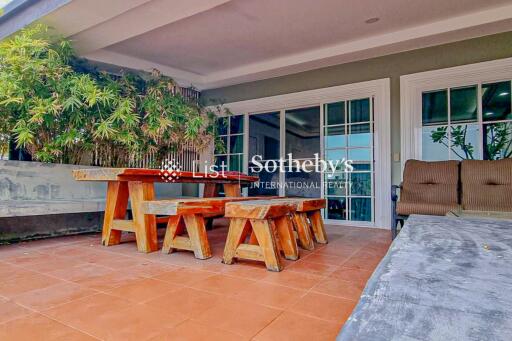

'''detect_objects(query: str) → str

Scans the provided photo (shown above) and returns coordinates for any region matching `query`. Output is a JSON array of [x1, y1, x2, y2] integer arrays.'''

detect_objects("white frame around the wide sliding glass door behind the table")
[[212, 78, 391, 229]]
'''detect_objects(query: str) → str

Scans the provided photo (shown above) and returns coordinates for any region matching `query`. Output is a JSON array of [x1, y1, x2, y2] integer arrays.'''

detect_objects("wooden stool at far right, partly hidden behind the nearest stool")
[[276, 198, 327, 250]]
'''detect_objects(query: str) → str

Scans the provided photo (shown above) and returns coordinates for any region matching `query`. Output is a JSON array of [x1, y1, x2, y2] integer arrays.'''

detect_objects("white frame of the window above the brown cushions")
[[400, 58, 512, 175]]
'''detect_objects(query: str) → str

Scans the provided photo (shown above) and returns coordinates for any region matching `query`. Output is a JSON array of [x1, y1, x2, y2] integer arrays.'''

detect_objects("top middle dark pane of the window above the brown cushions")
[[450, 85, 478, 122]]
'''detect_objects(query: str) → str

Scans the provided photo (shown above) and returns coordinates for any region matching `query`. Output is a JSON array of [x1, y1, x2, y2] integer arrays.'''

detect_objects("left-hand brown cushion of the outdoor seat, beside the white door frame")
[[397, 160, 459, 215]]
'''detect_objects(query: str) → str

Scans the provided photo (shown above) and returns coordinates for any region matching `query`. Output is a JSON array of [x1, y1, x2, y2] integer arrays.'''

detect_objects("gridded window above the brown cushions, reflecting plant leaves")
[[421, 80, 512, 161]]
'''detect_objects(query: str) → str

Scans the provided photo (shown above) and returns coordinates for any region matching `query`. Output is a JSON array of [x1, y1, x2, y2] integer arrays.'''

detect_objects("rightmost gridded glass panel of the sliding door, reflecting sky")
[[323, 98, 375, 222]]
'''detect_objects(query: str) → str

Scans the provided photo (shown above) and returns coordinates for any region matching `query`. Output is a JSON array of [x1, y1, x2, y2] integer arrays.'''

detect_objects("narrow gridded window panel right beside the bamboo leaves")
[[214, 115, 244, 172]]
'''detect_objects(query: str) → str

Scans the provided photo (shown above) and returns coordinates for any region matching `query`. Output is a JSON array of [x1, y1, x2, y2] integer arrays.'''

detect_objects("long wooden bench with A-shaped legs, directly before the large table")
[[142, 197, 269, 259]]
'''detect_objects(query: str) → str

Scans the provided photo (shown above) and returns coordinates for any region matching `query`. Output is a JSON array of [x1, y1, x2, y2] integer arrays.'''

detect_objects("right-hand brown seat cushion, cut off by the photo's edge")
[[461, 159, 512, 211]]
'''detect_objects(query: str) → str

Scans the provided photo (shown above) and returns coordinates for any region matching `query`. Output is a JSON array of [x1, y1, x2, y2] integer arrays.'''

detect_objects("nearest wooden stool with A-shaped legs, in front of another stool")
[[223, 200, 299, 271]]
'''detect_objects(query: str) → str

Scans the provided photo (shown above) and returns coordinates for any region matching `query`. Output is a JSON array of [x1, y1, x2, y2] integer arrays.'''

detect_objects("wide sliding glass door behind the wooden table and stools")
[[217, 97, 375, 224]]
